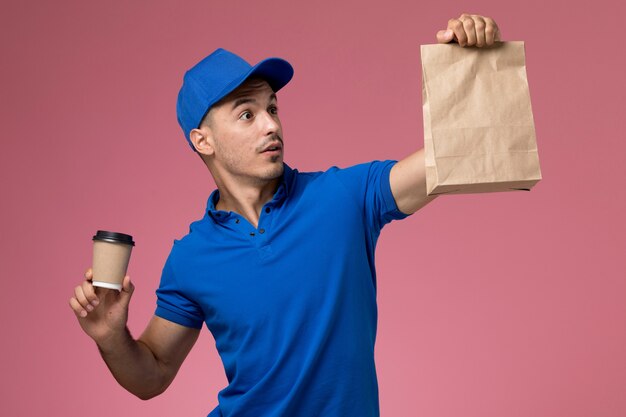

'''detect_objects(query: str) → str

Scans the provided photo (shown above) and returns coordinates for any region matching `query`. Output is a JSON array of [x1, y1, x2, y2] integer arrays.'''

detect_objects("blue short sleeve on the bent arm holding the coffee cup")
[[155, 250, 204, 329]]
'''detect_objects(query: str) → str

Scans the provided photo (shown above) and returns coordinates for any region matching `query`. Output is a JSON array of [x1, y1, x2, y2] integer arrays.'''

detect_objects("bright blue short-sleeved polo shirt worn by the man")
[[156, 161, 406, 417]]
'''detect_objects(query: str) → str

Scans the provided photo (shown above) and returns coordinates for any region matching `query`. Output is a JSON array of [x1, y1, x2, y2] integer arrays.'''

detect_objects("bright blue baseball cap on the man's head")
[[176, 48, 293, 151]]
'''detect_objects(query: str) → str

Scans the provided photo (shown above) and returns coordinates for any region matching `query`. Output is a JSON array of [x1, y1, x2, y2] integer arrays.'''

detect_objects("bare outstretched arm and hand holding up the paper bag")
[[389, 13, 500, 214]]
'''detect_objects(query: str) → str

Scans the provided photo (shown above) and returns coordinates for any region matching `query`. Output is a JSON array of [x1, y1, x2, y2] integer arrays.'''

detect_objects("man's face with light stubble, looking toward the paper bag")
[[194, 79, 283, 183]]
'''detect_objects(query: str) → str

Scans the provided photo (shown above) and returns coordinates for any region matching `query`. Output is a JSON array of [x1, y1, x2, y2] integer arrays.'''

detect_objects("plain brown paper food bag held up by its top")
[[421, 42, 541, 195]]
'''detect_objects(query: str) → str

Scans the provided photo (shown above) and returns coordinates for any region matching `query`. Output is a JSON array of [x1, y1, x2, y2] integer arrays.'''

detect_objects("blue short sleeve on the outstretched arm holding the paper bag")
[[337, 160, 408, 234]]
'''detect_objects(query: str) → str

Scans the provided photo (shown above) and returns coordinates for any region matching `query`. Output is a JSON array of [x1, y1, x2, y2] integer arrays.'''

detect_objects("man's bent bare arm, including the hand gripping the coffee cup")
[[70, 270, 200, 400]]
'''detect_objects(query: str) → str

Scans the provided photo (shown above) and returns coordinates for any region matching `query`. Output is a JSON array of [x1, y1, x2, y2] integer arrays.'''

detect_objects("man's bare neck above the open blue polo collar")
[[215, 177, 281, 228]]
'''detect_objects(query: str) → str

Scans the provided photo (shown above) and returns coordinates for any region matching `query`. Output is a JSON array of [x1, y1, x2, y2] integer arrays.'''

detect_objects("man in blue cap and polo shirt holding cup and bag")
[[70, 14, 500, 417]]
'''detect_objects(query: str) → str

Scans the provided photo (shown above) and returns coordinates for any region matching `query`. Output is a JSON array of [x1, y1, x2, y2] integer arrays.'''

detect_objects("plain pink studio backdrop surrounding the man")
[[0, 0, 626, 417]]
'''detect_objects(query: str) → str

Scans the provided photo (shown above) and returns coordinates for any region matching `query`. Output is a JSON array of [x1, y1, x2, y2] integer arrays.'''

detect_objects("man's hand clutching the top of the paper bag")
[[437, 13, 500, 47]]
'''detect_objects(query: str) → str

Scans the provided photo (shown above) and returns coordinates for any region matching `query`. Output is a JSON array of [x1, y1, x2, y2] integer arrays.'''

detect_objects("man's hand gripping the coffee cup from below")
[[70, 268, 135, 346]]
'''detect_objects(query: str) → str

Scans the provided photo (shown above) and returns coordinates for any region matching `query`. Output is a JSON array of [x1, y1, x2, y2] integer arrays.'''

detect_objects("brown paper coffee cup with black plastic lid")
[[92, 230, 135, 291]]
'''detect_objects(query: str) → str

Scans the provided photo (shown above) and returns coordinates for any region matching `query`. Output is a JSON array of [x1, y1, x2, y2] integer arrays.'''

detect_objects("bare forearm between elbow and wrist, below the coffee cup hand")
[[96, 328, 171, 400]]
